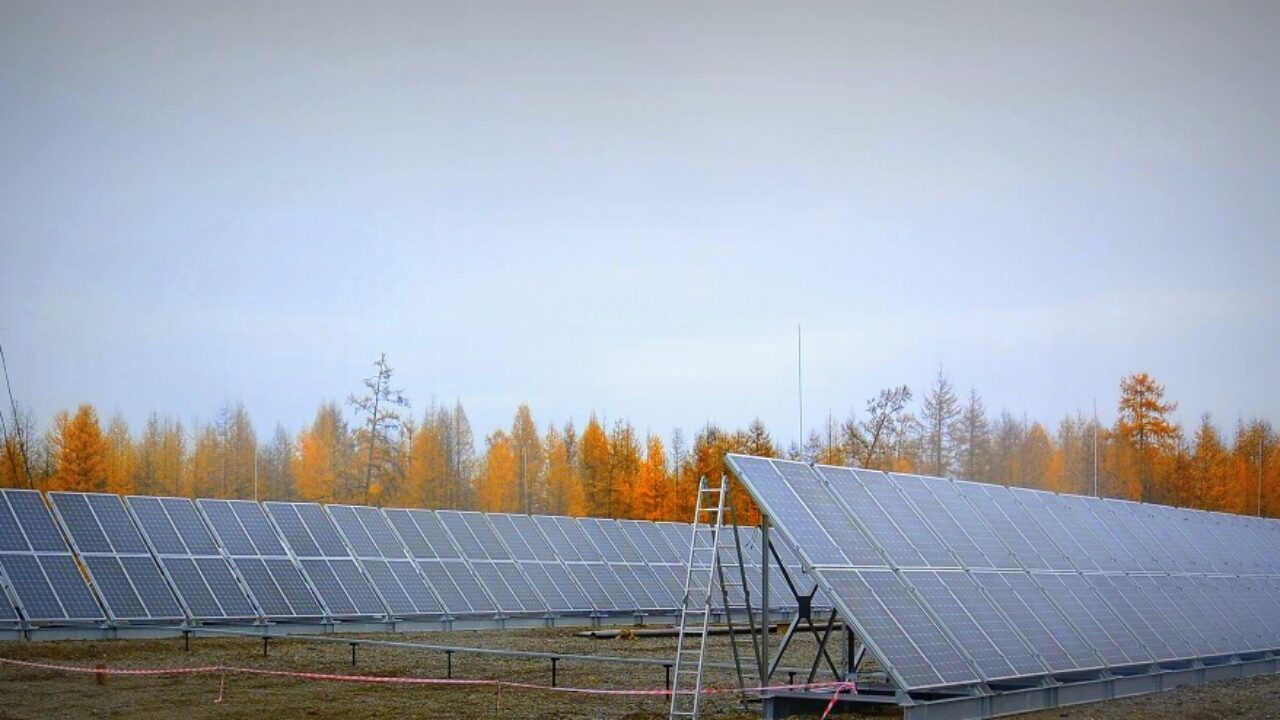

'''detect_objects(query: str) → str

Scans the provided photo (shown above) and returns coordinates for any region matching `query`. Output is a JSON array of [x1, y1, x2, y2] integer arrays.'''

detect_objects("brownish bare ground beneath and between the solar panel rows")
[[0, 629, 1280, 720]]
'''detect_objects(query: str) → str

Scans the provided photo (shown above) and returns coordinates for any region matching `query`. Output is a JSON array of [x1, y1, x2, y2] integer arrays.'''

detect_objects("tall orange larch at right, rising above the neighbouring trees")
[[1116, 373, 1181, 502]]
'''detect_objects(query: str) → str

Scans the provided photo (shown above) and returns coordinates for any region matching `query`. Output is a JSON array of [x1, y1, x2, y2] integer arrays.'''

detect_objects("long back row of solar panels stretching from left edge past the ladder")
[[0, 491, 814, 623]]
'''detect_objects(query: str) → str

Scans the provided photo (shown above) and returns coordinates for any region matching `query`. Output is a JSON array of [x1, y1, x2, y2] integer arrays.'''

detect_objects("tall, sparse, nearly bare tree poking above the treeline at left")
[[347, 352, 408, 503]]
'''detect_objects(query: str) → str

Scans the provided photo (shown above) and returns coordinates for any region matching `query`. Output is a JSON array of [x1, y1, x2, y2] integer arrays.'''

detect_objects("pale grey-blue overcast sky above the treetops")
[[0, 0, 1280, 442]]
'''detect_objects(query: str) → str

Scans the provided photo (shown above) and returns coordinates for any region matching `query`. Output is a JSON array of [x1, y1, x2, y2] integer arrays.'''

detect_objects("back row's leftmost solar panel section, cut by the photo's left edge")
[[0, 489, 106, 624]]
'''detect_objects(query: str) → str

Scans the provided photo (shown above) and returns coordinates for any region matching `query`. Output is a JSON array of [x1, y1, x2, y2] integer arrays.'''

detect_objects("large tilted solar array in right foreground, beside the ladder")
[[728, 455, 1280, 691]]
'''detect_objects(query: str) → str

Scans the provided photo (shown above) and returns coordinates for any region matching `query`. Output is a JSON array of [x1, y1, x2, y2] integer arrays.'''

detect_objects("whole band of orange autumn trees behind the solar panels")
[[0, 356, 1280, 523]]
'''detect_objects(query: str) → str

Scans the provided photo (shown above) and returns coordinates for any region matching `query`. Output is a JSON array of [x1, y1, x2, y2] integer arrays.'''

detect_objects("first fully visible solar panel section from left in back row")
[[49, 492, 184, 621]]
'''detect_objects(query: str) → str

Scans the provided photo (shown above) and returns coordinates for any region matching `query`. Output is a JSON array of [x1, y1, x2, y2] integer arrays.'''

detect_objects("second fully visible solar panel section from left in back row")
[[124, 496, 262, 621]]
